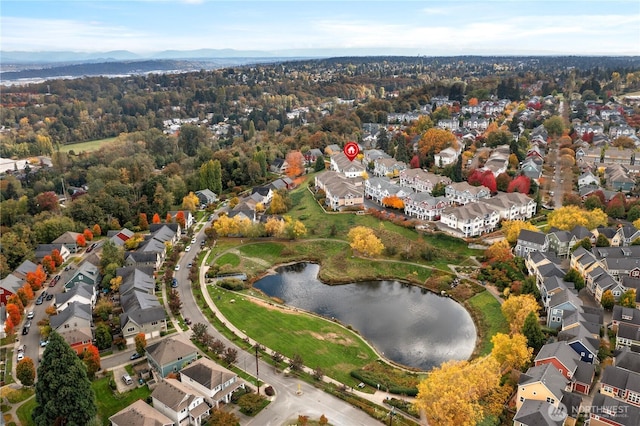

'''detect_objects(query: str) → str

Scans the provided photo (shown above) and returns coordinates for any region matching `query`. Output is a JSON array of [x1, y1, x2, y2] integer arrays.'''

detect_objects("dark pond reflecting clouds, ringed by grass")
[[253, 262, 476, 370]]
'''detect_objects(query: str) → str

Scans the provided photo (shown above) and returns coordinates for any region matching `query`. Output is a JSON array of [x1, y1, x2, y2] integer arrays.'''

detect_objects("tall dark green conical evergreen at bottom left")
[[31, 332, 98, 426]]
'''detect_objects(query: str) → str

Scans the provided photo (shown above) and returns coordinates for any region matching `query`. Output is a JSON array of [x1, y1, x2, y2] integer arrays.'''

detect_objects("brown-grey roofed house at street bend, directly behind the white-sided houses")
[[147, 336, 198, 377]]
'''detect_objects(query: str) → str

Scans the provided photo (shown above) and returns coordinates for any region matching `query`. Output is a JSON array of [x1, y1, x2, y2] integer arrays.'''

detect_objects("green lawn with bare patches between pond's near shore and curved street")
[[210, 288, 377, 384]]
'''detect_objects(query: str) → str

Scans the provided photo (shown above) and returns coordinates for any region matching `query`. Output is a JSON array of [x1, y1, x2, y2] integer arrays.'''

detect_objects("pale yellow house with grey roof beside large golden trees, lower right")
[[516, 364, 571, 410]]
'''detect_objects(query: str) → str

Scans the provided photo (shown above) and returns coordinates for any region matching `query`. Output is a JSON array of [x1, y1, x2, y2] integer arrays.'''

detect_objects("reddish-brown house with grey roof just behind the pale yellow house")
[[534, 342, 596, 395]]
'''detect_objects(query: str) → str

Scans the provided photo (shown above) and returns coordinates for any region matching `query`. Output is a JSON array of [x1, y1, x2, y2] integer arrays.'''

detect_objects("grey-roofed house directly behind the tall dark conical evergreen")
[[49, 302, 93, 354]]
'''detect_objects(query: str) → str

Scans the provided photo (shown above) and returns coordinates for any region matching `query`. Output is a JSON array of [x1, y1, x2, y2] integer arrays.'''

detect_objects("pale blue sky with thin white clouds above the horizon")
[[0, 0, 640, 56]]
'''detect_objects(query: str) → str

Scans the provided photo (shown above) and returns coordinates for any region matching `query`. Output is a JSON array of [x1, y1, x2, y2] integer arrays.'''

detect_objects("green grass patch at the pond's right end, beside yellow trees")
[[465, 290, 509, 356]]
